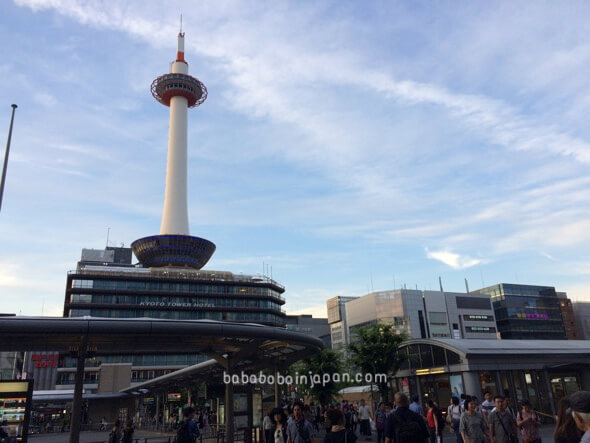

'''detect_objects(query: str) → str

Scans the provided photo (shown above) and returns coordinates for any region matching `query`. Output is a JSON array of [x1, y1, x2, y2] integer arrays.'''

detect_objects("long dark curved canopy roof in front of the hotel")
[[0, 317, 323, 369]]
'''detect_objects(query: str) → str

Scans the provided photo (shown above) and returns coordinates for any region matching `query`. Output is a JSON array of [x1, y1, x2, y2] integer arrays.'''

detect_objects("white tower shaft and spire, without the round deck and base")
[[160, 34, 190, 235]]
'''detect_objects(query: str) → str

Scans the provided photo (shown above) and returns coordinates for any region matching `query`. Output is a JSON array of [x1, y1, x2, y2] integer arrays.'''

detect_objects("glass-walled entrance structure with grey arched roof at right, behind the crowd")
[[393, 339, 590, 415]]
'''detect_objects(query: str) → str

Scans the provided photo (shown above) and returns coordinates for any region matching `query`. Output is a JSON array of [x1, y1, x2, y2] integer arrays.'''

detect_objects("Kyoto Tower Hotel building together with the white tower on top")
[[57, 32, 286, 390]]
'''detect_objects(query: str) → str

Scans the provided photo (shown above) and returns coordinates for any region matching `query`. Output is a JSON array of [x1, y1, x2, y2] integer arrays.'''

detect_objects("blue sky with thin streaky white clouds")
[[0, 0, 590, 315]]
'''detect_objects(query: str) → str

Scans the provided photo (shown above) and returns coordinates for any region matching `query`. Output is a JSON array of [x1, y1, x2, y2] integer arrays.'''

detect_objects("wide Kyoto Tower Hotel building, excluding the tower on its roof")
[[60, 248, 286, 391]]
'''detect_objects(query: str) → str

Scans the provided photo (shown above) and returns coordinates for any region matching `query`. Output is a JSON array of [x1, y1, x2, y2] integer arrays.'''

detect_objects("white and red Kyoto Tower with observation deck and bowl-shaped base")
[[131, 27, 215, 269]]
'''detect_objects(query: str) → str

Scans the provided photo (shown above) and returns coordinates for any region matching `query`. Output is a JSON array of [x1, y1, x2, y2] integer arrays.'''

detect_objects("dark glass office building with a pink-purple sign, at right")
[[474, 283, 566, 340]]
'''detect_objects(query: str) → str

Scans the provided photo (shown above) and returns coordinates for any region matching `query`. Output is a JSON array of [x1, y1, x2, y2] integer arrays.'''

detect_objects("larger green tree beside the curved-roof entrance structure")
[[348, 324, 408, 401]]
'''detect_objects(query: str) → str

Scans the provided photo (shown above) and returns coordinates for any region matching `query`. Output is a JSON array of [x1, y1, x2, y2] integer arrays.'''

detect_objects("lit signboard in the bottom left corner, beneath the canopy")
[[0, 380, 33, 442]]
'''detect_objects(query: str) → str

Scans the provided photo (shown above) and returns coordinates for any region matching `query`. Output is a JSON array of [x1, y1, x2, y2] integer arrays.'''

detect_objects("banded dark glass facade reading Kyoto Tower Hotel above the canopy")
[[64, 268, 286, 327]]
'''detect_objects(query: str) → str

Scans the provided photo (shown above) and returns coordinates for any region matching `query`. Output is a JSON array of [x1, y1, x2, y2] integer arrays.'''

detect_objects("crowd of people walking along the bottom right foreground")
[[263, 391, 590, 443]]
